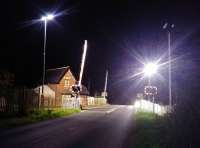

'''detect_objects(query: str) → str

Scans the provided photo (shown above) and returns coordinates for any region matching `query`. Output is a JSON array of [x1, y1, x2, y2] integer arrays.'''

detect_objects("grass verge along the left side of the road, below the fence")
[[0, 108, 80, 128]]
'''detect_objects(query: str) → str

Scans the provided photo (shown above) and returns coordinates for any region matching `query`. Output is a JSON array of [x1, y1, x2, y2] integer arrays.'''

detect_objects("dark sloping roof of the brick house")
[[46, 66, 70, 84]]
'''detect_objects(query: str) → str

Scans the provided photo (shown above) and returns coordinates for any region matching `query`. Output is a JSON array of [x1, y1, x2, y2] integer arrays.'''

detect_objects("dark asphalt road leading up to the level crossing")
[[0, 105, 133, 148]]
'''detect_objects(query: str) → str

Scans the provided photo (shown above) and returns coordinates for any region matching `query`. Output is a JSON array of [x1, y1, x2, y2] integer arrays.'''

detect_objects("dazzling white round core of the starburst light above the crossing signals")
[[143, 63, 158, 77]]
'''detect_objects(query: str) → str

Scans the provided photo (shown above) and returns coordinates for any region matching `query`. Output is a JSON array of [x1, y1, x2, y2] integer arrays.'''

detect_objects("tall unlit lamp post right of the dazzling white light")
[[163, 23, 174, 109]]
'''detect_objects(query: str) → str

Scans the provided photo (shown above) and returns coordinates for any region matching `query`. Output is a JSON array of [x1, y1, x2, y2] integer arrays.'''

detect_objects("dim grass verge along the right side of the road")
[[126, 112, 166, 148]]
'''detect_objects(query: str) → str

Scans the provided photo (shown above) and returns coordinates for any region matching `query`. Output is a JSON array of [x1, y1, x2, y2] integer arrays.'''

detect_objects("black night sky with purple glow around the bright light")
[[0, 0, 200, 103]]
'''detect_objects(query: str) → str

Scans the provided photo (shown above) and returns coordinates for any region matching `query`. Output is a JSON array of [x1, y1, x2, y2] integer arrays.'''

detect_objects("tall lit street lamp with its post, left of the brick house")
[[41, 14, 55, 107]]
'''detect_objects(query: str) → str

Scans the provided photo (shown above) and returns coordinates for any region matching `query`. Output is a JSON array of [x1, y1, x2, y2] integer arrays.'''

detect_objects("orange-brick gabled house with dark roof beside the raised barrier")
[[46, 66, 89, 108]]
